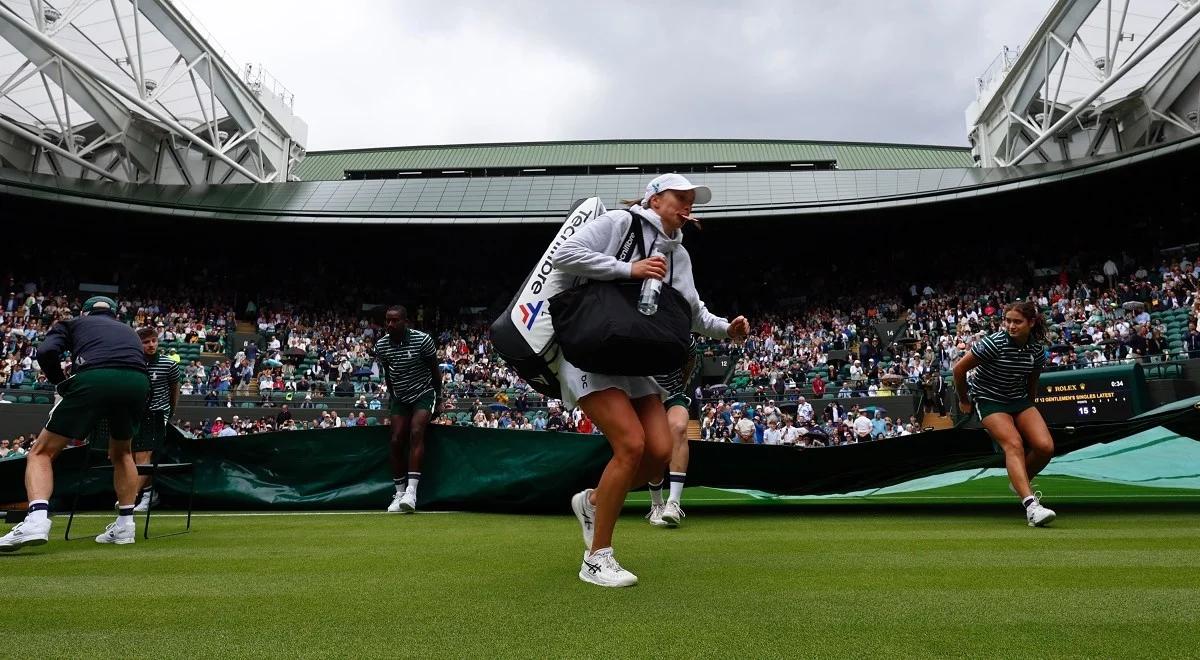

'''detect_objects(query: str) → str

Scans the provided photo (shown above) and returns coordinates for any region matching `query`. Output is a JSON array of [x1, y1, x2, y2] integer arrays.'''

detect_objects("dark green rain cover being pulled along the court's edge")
[[0, 397, 1200, 511]]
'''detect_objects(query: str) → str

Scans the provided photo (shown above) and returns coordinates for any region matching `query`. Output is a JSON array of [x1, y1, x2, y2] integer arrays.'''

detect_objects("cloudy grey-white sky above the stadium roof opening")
[[176, 0, 1050, 151]]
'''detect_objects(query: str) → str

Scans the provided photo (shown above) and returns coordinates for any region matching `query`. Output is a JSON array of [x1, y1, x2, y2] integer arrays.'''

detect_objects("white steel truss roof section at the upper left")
[[0, 0, 307, 184]]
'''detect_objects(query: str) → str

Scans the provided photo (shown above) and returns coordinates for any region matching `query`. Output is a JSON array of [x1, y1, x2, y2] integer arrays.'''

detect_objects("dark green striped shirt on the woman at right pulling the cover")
[[968, 330, 1046, 403]]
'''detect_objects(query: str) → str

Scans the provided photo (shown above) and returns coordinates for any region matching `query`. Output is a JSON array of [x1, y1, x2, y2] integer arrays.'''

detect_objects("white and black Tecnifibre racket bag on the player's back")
[[492, 197, 607, 398]]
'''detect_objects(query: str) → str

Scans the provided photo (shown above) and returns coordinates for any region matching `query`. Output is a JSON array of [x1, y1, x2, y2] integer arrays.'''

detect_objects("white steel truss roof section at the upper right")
[[966, 0, 1200, 167]]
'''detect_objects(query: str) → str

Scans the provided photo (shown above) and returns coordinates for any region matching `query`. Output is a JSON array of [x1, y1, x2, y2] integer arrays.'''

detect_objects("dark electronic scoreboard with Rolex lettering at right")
[[1033, 365, 1146, 424]]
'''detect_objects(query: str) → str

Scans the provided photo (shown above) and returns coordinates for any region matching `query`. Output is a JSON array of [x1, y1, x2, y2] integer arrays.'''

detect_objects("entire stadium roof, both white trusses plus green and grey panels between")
[[0, 0, 1200, 224]]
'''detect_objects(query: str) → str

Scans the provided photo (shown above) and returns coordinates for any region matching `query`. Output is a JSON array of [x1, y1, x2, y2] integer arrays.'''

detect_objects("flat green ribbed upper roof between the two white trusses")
[[295, 139, 972, 181]]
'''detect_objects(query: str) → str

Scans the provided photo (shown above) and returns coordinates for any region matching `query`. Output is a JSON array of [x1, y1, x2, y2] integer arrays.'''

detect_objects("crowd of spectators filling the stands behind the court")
[[0, 244, 1200, 457]]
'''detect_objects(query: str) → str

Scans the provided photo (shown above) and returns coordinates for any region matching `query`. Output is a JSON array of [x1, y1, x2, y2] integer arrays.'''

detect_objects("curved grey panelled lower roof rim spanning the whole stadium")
[[0, 136, 1200, 224]]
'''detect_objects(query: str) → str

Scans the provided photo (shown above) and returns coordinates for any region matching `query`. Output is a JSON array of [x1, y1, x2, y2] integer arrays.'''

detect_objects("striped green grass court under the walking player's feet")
[[0, 478, 1200, 658]]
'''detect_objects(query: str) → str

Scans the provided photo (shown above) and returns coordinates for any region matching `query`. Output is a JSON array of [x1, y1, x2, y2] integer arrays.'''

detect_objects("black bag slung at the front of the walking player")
[[550, 214, 691, 376]]
